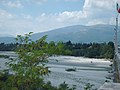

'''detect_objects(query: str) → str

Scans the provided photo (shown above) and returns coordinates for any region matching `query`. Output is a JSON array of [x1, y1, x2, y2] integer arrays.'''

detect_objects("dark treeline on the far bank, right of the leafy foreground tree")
[[64, 41, 114, 59]]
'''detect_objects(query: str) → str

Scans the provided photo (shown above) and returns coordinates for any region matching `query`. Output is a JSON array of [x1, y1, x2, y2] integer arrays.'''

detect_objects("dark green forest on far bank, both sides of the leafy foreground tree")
[[0, 41, 114, 59]]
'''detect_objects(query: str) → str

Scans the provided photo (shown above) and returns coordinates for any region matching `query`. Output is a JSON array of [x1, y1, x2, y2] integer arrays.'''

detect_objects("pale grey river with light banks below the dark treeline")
[[0, 52, 111, 90]]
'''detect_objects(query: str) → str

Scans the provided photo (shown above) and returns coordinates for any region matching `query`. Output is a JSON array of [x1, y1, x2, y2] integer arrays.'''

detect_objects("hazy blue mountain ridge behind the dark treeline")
[[0, 25, 120, 43]]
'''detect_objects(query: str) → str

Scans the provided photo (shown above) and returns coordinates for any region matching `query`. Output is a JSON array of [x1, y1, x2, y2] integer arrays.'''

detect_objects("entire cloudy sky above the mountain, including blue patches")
[[0, 0, 120, 36]]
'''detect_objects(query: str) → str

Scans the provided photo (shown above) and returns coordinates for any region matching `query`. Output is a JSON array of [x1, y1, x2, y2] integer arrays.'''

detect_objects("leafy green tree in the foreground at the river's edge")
[[7, 32, 63, 90]]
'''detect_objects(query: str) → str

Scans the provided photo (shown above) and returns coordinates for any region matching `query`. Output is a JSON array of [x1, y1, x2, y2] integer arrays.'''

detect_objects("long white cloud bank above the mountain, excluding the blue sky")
[[0, 0, 116, 35]]
